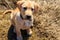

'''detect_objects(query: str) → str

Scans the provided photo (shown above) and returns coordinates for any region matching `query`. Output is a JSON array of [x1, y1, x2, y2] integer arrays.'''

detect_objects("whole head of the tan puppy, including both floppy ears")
[[17, 1, 39, 26]]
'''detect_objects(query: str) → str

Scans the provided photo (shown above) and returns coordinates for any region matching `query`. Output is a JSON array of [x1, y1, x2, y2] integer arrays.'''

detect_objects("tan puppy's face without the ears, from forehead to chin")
[[20, 1, 34, 21]]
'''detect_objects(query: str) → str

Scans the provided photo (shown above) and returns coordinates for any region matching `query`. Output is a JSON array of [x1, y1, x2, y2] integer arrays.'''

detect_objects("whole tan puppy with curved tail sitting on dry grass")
[[3, 1, 39, 40]]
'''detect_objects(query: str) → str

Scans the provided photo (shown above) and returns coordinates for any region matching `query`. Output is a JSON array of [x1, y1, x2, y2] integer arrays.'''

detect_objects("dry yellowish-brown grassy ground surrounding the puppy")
[[0, 0, 60, 40]]
